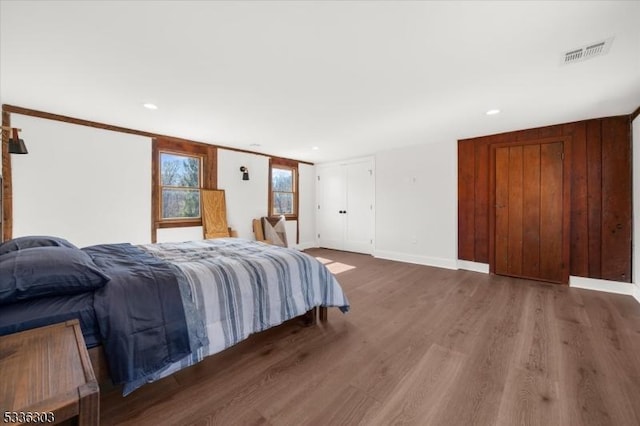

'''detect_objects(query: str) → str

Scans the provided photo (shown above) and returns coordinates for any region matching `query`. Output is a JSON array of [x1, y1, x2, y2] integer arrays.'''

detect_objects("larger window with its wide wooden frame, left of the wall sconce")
[[151, 138, 217, 236]]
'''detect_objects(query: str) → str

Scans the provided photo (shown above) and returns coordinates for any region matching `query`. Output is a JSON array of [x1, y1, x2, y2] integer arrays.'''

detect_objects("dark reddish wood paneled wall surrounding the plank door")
[[458, 115, 632, 282]]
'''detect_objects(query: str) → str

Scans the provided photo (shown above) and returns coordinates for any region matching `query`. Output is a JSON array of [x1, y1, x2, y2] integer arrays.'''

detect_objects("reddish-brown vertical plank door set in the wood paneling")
[[491, 139, 570, 283]]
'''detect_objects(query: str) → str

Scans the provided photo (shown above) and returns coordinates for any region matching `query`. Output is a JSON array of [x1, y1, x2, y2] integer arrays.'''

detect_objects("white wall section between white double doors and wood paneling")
[[375, 141, 458, 268]]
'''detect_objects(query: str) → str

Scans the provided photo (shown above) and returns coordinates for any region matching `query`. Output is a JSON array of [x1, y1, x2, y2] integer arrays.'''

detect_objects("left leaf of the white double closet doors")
[[317, 165, 346, 250]]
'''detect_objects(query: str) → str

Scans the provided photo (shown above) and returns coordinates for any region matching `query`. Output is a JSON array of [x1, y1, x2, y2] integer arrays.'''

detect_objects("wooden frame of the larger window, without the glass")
[[151, 138, 218, 242]]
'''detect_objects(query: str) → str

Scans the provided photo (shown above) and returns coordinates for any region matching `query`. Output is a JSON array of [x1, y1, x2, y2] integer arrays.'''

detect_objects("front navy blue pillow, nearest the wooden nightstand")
[[0, 247, 109, 305]]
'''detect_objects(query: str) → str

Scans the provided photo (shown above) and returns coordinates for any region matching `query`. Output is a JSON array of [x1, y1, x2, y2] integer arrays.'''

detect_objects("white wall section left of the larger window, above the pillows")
[[11, 114, 151, 246]]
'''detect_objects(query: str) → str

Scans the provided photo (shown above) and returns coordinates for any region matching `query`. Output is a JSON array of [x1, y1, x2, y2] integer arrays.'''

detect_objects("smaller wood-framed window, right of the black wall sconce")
[[269, 158, 298, 219]]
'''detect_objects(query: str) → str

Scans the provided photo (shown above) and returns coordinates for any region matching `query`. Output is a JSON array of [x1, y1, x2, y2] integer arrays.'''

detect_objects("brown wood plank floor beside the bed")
[[101, 249, 640, 426]]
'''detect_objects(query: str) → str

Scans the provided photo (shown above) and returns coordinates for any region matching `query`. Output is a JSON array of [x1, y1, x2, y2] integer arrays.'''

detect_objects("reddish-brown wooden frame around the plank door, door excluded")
[[488, 136, 572, 285]]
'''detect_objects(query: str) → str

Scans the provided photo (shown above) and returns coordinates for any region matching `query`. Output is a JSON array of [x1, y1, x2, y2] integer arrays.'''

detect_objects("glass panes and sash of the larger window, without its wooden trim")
[[160, 152, 202, 220]]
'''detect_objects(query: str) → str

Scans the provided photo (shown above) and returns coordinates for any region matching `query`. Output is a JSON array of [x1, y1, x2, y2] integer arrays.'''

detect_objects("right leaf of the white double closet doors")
[[344, 160, 375, 254]]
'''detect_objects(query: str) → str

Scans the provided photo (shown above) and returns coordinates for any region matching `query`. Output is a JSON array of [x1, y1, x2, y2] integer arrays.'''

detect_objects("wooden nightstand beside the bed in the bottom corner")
[[0, 320, 100, 425]]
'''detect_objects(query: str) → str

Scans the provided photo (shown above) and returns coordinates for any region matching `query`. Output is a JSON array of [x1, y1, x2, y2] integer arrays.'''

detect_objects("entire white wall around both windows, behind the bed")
[[6, 114, 315, 247]]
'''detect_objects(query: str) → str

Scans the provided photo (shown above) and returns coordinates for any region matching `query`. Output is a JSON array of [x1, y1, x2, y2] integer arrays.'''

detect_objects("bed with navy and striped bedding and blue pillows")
[[0, 237, 349, 395]]
